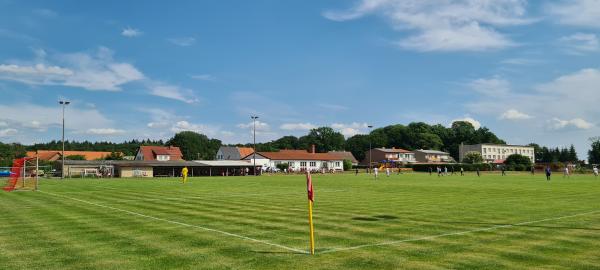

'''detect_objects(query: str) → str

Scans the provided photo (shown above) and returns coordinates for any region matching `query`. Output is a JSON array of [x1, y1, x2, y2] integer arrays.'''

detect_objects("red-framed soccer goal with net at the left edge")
[[0, 158, 38, 191]]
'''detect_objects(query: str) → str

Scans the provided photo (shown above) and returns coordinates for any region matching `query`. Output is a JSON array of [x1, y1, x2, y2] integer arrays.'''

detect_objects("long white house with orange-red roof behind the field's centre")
[[243, 146, 344, 172]]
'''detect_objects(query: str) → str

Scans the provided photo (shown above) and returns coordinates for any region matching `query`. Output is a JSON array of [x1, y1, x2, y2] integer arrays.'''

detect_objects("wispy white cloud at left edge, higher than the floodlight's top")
[[0, 47, 144, 91]]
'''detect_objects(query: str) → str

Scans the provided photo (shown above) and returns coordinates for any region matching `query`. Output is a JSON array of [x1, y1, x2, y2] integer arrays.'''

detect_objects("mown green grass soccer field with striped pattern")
[[0, 174, 600, 269]]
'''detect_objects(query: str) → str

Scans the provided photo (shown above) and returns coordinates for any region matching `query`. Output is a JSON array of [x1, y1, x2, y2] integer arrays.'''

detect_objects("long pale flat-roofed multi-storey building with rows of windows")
[[458, 143, 535, 163]]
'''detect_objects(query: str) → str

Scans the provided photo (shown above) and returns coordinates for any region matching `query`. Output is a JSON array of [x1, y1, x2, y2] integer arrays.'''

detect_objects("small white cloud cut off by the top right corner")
[[546, 0, 600, 28]]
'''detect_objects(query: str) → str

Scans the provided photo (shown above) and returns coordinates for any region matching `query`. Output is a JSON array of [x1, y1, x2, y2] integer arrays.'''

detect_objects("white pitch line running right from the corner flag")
[[319, 210, 600, 253]]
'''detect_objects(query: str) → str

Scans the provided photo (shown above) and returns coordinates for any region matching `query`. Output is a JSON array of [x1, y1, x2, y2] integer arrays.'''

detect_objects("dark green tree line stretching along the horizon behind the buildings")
[[0, 121, 600, 166]]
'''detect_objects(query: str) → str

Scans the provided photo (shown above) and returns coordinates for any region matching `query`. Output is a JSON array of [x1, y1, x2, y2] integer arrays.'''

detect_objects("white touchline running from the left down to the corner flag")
[[40, 191, 308, 254]]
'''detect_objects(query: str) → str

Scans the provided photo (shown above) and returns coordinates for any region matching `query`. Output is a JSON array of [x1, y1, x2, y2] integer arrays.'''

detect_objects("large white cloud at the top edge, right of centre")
[[323, 0, 534, 51]]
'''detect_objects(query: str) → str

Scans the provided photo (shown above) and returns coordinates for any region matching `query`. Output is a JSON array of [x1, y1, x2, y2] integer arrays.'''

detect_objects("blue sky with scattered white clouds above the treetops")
[[0, 0, 600, 157]]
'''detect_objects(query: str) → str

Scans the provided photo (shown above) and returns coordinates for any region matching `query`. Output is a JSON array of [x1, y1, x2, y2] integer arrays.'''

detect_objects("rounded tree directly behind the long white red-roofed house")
[[298, 127, 345, 153]]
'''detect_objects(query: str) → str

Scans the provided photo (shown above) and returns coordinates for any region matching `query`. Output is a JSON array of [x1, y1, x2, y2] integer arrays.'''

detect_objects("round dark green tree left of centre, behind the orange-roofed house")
[[167, 131, 221, 160]]
